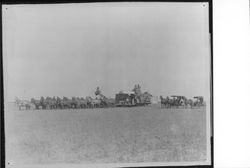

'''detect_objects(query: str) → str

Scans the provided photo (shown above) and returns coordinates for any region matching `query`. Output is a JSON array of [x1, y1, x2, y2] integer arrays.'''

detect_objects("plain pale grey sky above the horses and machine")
[[2, 2, 211, 101]]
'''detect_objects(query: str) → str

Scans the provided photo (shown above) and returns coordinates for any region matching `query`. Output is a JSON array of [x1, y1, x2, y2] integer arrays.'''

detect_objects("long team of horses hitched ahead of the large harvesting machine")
[[15, 96, 115, 110]]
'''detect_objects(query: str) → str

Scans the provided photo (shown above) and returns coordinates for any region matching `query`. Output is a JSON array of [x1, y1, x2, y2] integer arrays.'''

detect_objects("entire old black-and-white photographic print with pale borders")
[[2, 2, 213, 167]]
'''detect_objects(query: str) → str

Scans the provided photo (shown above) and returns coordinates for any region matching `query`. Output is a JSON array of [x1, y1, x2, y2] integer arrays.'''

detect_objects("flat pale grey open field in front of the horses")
[[5, 104, 206, 165]]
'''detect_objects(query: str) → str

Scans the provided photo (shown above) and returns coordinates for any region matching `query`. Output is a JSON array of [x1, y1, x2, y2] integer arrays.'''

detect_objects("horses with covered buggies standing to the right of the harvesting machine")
[[160, 96, 206, 108]]
